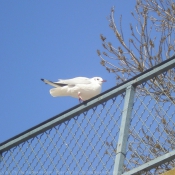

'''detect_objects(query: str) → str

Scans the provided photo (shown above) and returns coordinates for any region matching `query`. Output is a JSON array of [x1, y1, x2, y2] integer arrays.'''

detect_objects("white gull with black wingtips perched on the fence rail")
[[41, 77, 106, 102]]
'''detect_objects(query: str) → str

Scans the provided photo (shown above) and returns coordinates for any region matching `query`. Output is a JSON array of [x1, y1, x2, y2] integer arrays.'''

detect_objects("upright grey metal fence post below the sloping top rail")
[[113, 85, 135, 175]]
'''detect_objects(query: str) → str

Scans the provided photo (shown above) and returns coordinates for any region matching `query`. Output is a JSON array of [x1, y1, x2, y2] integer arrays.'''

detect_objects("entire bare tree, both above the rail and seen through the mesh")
[[97, 0, 175, 174]]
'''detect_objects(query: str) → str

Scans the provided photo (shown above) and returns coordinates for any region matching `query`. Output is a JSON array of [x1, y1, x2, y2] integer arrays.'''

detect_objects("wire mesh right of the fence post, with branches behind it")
[[125, 69, 175, 175]]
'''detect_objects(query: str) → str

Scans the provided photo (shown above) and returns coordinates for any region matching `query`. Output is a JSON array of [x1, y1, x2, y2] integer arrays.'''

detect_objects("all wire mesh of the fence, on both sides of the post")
[[0, 62, 175, 175]]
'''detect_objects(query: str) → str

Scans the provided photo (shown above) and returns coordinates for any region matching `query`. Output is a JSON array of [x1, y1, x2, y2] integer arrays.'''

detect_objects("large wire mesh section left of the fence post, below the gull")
[[1, 94, 124, 175]]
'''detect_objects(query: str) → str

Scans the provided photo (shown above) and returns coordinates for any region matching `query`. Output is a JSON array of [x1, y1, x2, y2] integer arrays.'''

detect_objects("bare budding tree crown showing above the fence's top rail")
[[97, 0, 175, 82]]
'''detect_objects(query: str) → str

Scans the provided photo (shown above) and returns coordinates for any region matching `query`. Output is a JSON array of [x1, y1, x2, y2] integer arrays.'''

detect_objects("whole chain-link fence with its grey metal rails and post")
[[0, 58, 175, 175]]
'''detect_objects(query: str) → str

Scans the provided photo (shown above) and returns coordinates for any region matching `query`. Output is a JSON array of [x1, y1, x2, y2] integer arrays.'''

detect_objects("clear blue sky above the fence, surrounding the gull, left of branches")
[[0, 0, 135, 142]]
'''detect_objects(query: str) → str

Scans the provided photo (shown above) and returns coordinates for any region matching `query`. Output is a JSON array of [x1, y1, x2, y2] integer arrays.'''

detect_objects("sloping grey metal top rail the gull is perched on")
[[0, 55, 175, 153]]
